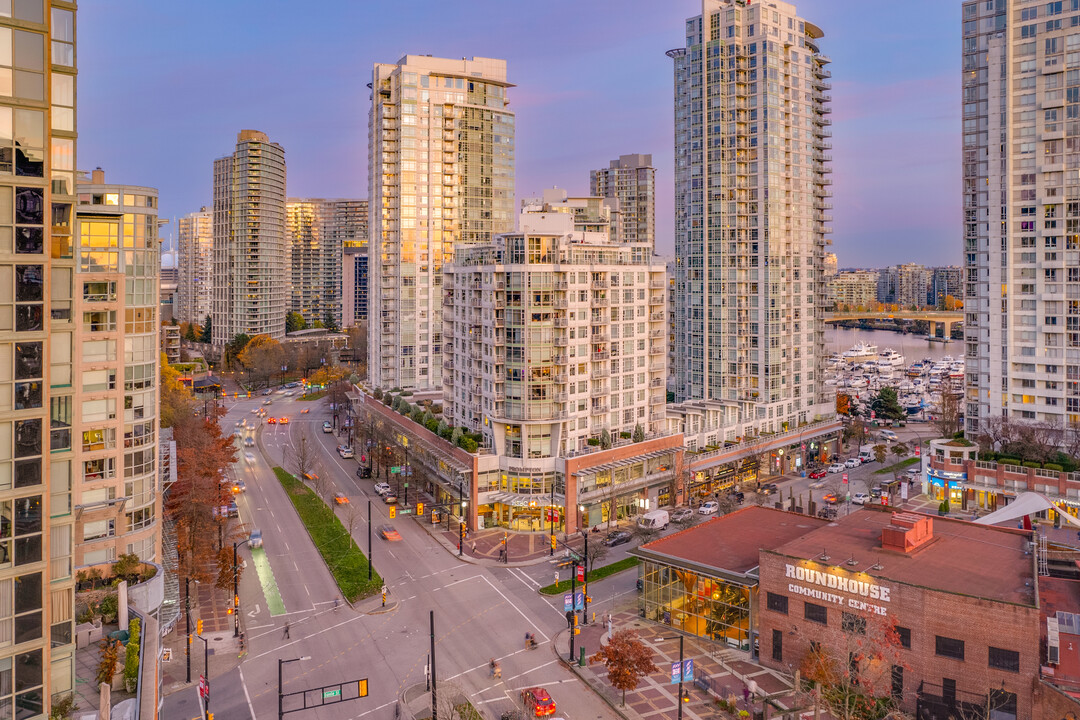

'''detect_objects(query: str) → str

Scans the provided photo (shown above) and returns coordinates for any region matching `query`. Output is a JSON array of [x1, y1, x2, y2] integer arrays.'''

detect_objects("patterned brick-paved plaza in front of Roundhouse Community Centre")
[[554, 603, 795, 720]]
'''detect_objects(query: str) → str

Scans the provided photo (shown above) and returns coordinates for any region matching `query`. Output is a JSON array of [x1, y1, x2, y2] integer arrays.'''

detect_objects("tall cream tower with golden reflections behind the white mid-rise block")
[[367, 55, 514, 392]]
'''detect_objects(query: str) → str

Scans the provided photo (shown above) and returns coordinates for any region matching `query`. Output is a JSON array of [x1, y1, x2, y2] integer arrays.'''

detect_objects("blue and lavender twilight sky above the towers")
[[78, 0, 961, 268]]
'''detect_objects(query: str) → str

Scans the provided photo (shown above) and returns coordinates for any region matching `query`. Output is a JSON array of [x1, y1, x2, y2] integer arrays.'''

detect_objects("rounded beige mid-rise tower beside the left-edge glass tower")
[[72, 171, 161, 568]]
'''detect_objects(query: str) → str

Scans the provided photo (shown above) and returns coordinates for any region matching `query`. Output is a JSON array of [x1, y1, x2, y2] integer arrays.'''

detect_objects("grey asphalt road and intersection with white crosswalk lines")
[[166, 394, 636, 720]]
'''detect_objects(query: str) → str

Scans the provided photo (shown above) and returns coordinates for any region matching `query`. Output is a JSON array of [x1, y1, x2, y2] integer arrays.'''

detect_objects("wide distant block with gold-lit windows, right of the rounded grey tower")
[[285, 198, 367, 328]]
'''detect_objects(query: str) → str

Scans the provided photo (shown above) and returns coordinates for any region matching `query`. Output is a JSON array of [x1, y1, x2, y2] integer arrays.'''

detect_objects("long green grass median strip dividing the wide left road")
[[273, 467, 382, 602]]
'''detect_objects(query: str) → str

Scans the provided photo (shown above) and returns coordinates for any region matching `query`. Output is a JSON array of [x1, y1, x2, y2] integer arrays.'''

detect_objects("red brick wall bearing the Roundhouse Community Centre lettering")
[[758, 552, 1042, 720]]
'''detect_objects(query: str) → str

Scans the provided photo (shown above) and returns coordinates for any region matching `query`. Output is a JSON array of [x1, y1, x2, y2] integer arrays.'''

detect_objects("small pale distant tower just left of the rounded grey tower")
[[176, 207, 214, 327]]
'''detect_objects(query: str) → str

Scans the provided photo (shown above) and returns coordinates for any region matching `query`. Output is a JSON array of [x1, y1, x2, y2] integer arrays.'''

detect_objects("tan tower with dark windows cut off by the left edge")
[[0, 0, 78, 719]]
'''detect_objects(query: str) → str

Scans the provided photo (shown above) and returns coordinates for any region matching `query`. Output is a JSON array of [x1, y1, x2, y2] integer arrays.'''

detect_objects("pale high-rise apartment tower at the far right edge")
[[961, 0, 1080, 437]]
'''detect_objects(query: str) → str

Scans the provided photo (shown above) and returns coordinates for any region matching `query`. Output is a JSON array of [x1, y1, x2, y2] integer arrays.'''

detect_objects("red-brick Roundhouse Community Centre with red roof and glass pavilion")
[[631, 506, 1062, 720]]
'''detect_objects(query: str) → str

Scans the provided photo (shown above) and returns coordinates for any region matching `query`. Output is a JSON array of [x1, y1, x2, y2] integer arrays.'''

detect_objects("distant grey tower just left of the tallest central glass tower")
[[589, 153, 657, 247]]
